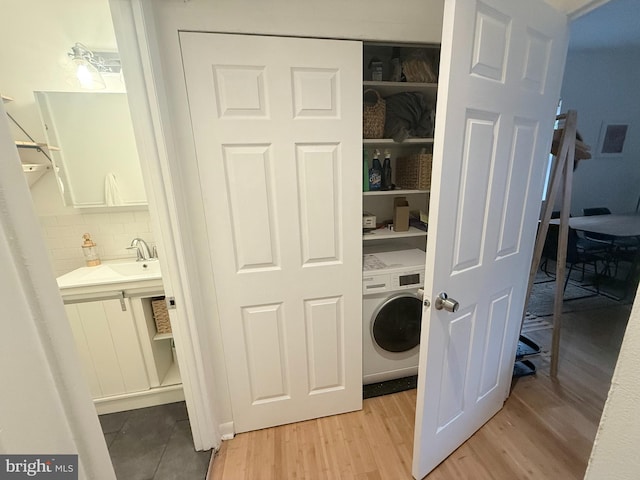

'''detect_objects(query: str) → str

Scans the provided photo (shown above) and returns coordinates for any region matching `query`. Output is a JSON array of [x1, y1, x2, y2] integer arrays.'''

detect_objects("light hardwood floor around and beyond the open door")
[[207, 305, 631, 480]]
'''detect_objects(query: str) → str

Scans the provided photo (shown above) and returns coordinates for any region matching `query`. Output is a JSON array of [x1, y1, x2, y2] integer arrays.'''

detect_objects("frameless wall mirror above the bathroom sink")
[[34, 92, 147, 208]]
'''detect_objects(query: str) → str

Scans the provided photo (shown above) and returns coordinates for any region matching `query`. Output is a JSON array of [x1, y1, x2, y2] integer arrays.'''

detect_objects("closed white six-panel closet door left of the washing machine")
[[180, 32, 362, 432]]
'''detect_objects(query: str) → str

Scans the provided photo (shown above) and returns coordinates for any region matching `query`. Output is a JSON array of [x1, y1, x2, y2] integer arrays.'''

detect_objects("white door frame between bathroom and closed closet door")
[[109, 0, 222, 450]]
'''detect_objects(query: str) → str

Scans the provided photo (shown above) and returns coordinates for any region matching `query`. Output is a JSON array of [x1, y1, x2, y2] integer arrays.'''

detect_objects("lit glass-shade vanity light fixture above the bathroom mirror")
[[67, 43, 122, 90]]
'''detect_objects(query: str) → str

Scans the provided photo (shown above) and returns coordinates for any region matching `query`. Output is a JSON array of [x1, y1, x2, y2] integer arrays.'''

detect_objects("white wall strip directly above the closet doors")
[[153, 0, 444, 43]]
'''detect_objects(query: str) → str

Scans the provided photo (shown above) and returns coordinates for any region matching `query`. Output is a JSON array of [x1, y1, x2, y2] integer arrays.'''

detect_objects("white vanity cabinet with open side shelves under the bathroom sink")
[[61, 280, 184, 414]]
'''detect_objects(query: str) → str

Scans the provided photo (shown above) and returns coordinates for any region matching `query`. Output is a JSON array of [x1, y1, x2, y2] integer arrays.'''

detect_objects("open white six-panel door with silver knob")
[[413, 0, 567, 478]]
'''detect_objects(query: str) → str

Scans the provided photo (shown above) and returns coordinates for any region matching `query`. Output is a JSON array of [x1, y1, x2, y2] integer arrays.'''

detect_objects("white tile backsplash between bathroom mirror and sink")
[[39, 210, 155, 276]]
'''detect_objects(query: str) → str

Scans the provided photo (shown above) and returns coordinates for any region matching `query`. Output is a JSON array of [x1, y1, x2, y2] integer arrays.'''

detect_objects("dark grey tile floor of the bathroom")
[[99, 402, 211, 480]]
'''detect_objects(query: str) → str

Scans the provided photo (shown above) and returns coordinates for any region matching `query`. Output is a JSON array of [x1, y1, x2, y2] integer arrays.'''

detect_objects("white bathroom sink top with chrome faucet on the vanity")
[[57, 259, 162, 289]]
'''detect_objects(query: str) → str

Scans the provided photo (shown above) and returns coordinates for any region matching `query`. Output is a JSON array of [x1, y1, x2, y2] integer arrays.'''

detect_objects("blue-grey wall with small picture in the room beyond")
[[562, 47, 640, 215]]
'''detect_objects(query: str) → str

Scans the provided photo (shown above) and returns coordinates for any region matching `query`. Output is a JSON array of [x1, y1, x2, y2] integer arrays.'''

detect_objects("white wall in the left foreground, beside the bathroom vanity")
[[0, 99, 115, 480]]
